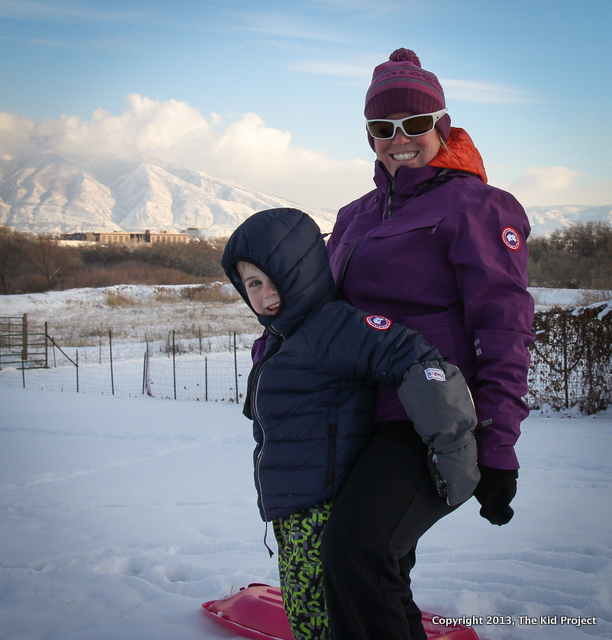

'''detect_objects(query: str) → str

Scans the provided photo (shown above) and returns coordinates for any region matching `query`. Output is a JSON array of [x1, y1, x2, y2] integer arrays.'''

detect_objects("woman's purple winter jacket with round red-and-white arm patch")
[[328, 162, 533, 469]]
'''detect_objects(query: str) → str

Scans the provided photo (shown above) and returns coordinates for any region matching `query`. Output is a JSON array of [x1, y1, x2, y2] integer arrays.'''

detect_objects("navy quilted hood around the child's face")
[[221, 209, 334, 337]]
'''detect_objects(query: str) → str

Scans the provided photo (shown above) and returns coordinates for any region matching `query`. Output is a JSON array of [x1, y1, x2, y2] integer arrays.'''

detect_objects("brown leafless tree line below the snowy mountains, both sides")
[[0, 222, 612, 294]]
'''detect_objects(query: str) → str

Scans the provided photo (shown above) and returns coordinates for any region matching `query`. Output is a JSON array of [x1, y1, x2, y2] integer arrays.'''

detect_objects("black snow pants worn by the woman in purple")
[[321, 421, 456, 640]]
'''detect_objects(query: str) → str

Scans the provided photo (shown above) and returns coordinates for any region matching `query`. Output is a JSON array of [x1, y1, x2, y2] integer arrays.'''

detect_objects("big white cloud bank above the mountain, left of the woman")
[[0, 94, 372, 209]]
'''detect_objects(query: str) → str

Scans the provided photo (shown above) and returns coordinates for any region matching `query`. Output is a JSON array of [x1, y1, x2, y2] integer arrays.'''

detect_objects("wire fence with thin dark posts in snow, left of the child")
[[0, 331, 257, 403]]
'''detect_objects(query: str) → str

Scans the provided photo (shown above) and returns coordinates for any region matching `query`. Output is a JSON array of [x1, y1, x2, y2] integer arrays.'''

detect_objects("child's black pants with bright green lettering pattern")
[[273, 501, 333, 640]]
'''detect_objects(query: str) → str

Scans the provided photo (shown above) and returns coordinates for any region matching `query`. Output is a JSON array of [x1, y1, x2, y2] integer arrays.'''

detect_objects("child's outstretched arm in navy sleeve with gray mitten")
[[308, 303, 480, 505]]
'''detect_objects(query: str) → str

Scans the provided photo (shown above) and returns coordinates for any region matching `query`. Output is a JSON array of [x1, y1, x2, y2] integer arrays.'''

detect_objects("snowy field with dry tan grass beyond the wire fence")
[[0, 285, 612, 348]]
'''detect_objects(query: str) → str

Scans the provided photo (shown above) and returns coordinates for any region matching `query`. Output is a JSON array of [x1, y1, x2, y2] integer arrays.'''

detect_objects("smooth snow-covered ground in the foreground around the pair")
[[0, 292, 612, 640]]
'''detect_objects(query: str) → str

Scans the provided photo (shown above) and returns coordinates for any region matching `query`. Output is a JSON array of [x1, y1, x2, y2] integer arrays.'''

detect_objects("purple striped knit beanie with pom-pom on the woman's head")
[[365, 49, 450, 148]]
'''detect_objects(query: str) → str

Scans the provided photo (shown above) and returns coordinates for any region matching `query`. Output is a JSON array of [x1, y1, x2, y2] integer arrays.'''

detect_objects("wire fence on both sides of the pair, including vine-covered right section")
[[0, 303, 612, 414]]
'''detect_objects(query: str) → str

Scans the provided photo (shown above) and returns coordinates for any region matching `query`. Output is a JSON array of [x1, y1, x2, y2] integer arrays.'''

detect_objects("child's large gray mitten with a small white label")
[[398, 360, 480, 506]]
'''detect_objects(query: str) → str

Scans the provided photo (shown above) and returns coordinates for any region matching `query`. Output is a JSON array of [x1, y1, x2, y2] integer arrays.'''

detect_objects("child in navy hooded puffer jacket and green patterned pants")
[[222, 209, 479, 639]]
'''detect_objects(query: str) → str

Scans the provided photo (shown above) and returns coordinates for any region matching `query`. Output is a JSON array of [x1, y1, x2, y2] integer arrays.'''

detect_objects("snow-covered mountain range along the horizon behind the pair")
[[0, 153, 612, 236]]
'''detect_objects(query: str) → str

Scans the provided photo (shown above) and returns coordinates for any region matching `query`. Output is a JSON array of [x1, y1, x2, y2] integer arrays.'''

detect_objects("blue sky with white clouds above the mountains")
[[0, 0, 612, 209]]
